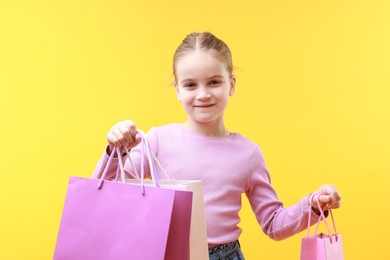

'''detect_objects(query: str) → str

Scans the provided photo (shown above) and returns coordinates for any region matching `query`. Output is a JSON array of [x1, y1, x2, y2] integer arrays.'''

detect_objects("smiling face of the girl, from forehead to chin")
[[175, 51, 236, 124]]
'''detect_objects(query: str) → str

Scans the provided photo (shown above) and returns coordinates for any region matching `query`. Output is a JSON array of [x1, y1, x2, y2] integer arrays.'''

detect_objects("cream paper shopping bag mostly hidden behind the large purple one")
[[126, 179, 209, 260]]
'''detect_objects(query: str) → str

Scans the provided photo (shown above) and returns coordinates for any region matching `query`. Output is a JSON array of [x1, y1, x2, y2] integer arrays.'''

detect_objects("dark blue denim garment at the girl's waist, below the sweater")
[[209, 240, 245, 260]]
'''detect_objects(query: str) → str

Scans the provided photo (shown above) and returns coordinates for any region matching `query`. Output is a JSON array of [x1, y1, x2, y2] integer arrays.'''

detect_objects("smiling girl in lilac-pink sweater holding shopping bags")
[[93, 33, 340, 260]]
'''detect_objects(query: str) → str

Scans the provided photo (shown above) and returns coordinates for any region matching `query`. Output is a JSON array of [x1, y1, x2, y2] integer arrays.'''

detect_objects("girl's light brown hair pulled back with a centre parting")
[[173, 32, 233, 77]]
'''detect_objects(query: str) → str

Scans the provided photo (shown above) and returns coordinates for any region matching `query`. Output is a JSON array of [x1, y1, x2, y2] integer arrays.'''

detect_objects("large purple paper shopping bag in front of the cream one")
[[54, 130, 192, 260]]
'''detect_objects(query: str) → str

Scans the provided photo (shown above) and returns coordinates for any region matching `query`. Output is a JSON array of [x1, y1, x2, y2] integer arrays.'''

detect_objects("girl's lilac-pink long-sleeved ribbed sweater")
[[93, 124, 318, 247]]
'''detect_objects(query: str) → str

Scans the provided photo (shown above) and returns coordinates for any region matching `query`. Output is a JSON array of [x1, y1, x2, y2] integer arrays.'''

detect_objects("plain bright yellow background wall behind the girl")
[[0, 0, 390, 260]]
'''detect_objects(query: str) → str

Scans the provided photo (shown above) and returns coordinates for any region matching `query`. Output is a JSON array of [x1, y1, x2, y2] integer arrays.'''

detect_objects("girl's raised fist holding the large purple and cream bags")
[[106, 120, 141, 154]]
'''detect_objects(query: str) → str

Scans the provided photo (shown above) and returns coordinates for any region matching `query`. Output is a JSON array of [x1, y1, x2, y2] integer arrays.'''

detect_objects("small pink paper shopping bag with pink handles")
[[301, 195, 344, 260]]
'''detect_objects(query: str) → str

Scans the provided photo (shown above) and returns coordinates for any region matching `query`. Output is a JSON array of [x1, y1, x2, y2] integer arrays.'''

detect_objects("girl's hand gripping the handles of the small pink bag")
[[309, 184, 341, 210]]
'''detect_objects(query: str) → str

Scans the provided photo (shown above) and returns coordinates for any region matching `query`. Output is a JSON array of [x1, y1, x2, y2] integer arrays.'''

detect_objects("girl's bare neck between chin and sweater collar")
[[182, 120, 230, 137]]
